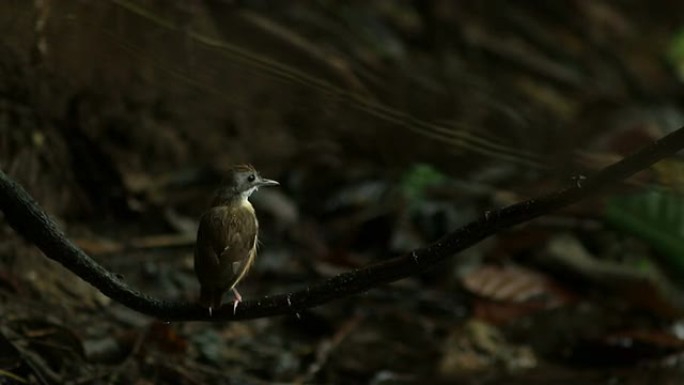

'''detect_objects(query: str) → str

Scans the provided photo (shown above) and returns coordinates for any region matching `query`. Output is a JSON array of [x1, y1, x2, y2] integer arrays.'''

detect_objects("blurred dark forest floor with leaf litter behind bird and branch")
[[0, 0, 684, 384]]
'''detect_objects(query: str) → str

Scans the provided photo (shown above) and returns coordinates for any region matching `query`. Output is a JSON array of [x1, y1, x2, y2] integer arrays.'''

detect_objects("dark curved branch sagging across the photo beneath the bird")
[[0, 128, 684, 321]]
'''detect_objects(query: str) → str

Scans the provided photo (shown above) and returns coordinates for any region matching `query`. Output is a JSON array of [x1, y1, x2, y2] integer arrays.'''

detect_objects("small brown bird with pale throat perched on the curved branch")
[[195, 166, 279, 315]]
